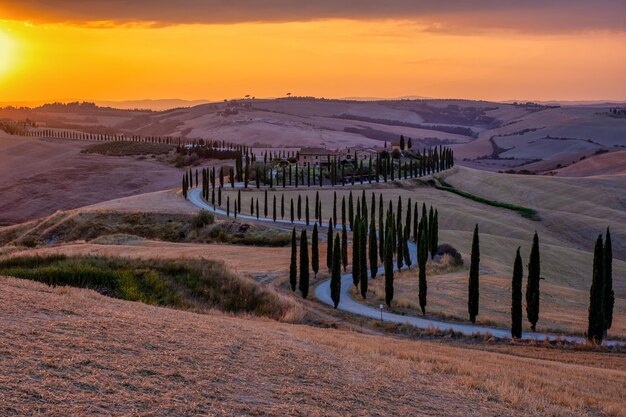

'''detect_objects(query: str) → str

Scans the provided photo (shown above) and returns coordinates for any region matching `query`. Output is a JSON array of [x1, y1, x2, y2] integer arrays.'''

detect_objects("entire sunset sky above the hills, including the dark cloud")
[[0, 0, 626, 103]]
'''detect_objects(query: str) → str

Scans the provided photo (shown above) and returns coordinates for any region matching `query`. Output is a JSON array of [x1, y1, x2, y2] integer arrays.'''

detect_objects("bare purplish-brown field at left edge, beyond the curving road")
[[0, 131, 180, 225]]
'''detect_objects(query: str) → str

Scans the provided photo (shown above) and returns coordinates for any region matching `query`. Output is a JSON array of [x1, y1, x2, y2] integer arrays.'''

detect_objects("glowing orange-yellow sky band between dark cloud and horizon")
[[0, 14, 626, 102]]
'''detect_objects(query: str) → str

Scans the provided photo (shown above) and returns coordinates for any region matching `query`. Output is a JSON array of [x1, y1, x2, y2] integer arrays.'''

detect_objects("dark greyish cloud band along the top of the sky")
[[0, 0, 626, 32]]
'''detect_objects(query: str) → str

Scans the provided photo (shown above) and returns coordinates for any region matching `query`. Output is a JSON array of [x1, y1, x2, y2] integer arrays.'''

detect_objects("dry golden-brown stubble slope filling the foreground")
[[0, 278, 626, 416]]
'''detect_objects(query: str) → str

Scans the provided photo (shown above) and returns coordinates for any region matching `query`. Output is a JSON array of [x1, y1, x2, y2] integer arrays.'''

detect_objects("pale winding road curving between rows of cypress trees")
[[187, 187, 624, 346]]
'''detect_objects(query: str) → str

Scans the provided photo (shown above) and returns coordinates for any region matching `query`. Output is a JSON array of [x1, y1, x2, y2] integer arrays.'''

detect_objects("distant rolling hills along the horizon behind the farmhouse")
[[0, 98, 626, 172]]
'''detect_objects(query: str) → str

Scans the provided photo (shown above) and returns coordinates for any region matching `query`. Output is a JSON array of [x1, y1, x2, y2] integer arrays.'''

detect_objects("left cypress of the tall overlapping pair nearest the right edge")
[[587, 235, 605, 343]]
